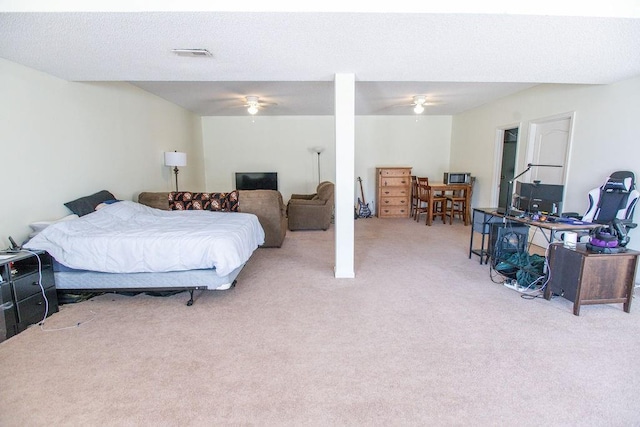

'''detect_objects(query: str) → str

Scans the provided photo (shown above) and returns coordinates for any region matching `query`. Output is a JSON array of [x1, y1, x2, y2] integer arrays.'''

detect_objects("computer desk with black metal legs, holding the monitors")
[[469, 208, 602, 264]]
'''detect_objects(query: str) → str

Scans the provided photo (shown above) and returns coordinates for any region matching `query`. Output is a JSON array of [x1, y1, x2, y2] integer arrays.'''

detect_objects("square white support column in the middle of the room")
[[334, 74, 355, 278]]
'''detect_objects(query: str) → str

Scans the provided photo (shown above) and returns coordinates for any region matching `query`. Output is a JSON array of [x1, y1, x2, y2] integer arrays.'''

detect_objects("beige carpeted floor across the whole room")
[[0, 218, 640, 426]]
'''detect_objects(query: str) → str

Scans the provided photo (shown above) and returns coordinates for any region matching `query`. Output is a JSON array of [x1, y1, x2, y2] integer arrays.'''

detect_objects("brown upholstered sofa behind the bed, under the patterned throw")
[[138, 190, 287, 248]]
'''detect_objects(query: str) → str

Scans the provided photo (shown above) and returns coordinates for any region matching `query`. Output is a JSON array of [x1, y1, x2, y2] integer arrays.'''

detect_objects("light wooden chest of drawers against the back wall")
[[376, 166, 411, 218]]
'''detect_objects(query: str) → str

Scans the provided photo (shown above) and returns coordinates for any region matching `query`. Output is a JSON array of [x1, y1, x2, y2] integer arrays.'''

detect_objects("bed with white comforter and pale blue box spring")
[[24, 201, 265, 305]]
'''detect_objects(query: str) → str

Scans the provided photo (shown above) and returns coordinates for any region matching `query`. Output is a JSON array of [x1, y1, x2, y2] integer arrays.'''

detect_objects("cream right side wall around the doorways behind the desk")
[[451, 77, 640, 248]]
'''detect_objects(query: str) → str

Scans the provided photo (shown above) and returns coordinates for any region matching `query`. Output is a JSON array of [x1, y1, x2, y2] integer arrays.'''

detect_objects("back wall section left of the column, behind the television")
[[202, 116, 336, 201]]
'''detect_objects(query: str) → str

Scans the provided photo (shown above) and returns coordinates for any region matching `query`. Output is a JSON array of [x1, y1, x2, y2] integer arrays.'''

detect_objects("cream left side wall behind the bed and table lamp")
[[0, 59, 204, 247]]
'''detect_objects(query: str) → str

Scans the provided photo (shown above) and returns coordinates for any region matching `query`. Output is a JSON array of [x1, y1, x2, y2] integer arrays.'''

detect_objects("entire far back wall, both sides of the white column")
[[202, 116, 451, 211]]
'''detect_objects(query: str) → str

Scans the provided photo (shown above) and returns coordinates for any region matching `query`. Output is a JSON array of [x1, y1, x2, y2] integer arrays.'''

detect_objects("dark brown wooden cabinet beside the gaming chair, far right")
[[544, 243, 640, 316]]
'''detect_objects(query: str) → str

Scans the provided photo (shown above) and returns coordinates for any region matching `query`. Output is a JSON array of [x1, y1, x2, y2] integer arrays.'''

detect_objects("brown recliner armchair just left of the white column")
[[287, 181, 334, 231]]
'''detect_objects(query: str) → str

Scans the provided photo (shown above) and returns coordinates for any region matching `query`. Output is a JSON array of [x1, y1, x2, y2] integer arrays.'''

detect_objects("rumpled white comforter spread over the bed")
[[24, 201, 264, 276]]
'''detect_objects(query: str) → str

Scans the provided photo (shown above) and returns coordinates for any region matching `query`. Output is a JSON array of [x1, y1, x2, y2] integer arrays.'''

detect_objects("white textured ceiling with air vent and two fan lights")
[[0, 0, 640, 116]]
